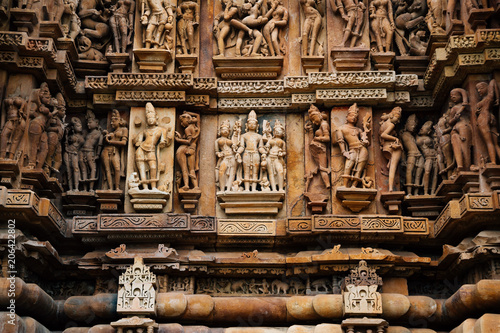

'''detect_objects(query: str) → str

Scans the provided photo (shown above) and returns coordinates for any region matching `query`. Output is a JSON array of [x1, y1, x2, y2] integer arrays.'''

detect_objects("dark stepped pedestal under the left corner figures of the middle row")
[[21, 168, 64, 199]]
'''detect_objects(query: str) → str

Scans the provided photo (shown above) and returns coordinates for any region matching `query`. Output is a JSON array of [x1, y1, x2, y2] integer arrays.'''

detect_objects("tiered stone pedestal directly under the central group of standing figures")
[[217, 191, 285, 215]]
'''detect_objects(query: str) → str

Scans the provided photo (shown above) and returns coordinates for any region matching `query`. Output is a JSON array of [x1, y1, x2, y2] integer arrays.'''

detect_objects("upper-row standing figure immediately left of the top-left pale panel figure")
[[109, 0, 135, 53]]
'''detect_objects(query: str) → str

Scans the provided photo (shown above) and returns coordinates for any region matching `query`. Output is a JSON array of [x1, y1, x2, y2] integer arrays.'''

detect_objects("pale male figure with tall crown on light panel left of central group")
[[132, 102, 172, 190]]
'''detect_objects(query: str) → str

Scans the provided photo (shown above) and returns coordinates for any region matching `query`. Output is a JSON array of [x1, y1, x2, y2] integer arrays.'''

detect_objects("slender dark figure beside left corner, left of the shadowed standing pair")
[[44, 93, 66, 176]]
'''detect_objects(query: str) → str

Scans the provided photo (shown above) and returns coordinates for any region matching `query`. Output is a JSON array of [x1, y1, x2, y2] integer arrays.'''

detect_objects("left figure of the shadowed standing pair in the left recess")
[[64, 117, 85, 192]]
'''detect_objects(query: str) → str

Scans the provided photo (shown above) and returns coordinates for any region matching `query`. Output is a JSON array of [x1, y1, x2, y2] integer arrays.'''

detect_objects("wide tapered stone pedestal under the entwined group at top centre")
[[212, 56, 283, 80]]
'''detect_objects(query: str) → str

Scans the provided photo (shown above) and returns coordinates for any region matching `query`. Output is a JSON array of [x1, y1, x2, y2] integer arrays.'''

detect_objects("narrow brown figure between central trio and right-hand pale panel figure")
[[305, 104, 331, 191]]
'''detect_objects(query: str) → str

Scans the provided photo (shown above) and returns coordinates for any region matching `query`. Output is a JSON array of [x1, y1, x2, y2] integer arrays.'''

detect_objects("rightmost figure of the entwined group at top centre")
[[262, 0, 288, 57]]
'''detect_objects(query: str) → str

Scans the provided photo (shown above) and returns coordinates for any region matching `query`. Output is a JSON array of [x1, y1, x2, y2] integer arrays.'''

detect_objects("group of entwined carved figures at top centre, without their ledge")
[[213, 0, 288, 57]]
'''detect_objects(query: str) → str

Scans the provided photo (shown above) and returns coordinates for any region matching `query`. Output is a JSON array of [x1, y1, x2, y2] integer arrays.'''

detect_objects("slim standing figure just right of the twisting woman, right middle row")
[[401, 114, 425, 195]]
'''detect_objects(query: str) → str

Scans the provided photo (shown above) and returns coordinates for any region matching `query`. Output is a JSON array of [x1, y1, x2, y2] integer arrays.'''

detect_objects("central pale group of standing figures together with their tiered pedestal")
[[215, 110, 286, 214]]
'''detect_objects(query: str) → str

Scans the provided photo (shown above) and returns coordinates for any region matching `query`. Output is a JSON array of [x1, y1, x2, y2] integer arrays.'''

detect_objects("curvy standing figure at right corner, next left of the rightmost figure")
[[449, 88, 472, 172]]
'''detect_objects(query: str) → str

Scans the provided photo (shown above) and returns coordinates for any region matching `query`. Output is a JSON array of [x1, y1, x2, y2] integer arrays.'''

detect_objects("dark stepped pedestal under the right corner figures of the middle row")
[[436, 171, 479, 201]]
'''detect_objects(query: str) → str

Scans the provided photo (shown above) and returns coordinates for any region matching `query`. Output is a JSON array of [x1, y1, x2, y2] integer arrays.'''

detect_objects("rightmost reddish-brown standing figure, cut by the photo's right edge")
[[476, 80, 500, 164]]
